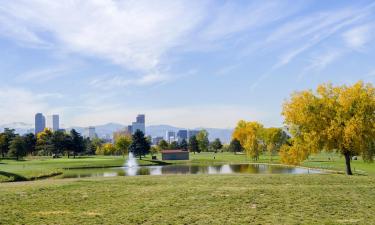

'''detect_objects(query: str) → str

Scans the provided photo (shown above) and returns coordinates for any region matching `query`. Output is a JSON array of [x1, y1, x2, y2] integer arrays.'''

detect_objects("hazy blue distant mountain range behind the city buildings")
[[0, 122, 233, 143]]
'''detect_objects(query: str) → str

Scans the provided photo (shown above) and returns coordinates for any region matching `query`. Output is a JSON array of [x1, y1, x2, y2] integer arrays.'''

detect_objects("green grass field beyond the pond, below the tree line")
[[0, 153, 375, 182]]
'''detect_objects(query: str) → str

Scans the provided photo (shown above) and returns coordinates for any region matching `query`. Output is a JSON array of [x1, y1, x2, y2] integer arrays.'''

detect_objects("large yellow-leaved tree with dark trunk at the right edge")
[[280, 81, 375, 175]]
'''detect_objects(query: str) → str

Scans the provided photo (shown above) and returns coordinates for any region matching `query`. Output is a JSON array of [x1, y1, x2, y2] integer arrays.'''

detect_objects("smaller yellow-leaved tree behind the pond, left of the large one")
[[232, 120, 263, 160]]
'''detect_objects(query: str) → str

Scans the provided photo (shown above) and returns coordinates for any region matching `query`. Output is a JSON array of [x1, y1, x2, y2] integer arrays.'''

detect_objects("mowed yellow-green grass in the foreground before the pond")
[[0, 174, 375, 224]]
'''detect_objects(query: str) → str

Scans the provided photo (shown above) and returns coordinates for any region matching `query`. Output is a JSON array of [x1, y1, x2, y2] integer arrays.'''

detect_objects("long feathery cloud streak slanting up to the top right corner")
[[265, 3, 375, 68]]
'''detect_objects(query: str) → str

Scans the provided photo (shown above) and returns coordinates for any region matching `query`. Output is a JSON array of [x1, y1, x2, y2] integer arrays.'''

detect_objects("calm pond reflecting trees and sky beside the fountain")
[[58, 164, 322, 178]]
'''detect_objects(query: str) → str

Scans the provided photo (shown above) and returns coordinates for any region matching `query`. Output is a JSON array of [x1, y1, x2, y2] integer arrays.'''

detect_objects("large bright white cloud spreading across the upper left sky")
[[0, 0, 209, 71]]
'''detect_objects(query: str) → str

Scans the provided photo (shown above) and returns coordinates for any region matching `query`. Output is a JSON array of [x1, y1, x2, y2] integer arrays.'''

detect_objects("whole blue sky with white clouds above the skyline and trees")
[[0, 0, 375, 128]]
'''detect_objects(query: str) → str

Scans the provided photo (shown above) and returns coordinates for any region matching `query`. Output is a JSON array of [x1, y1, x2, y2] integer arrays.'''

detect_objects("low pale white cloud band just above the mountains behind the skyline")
[[72, 105, 274, 128]]
